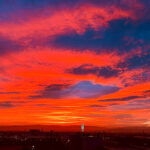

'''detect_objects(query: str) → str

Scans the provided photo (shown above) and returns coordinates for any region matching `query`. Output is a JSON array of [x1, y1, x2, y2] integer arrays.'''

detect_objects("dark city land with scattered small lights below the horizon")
[[0, 130, 150, 150]]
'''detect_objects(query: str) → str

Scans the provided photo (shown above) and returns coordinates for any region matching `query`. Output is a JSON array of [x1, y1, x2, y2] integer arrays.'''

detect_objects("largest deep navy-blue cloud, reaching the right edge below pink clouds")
[[53, 19, 150, 53]]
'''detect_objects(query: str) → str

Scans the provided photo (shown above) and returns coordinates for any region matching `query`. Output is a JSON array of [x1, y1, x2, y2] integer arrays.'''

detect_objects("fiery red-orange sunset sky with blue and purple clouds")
[[0, 0, 150, 127]]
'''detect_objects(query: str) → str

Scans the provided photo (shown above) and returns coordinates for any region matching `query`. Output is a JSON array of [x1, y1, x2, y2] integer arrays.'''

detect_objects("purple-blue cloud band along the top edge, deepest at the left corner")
[[0, 0, 113, 20]]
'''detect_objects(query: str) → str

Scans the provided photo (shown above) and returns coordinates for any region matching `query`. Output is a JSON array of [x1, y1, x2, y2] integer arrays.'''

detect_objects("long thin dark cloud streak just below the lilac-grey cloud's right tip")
[[98, 95, 146, 102]]
